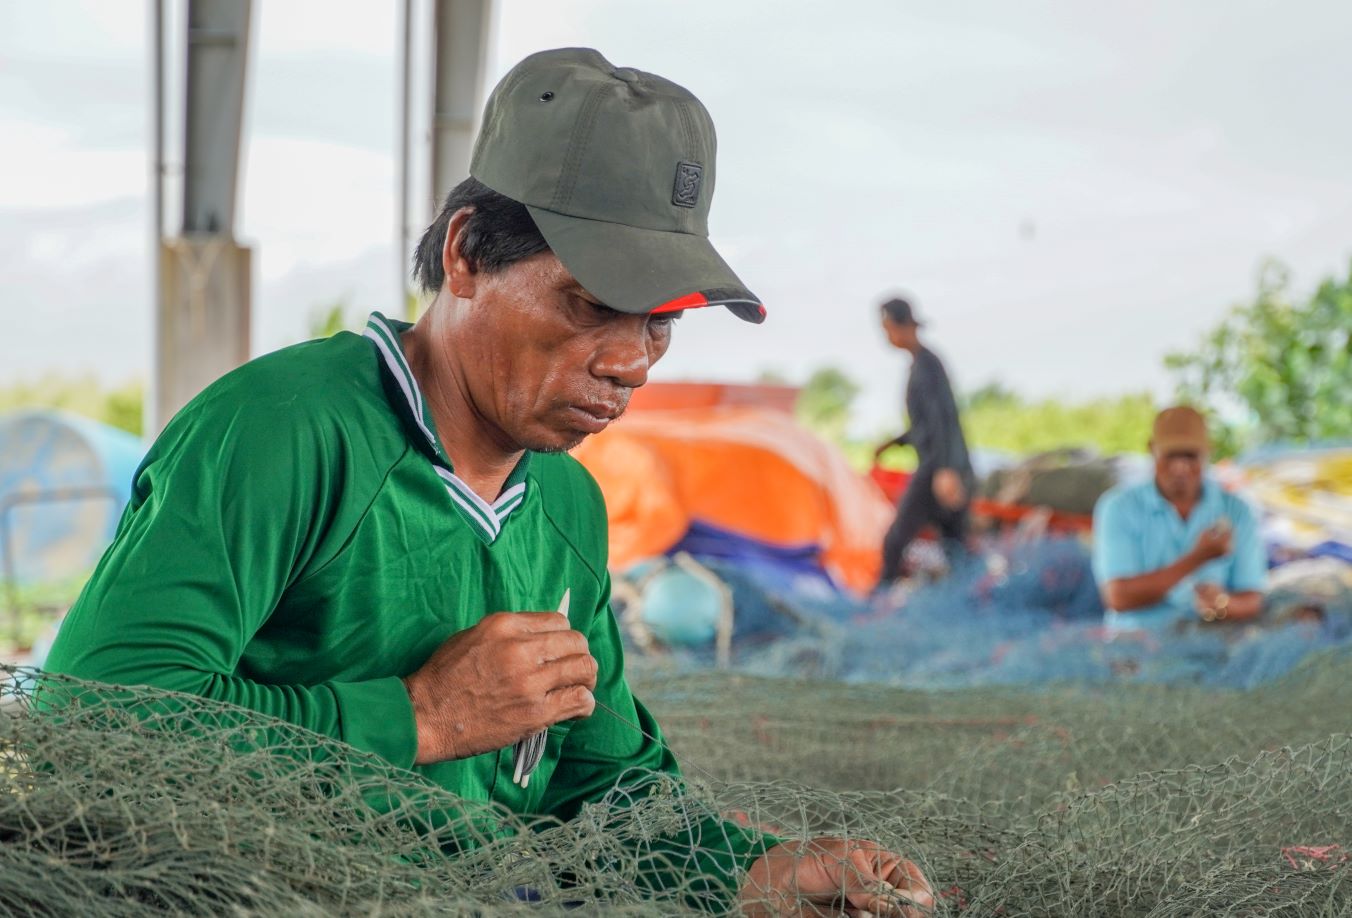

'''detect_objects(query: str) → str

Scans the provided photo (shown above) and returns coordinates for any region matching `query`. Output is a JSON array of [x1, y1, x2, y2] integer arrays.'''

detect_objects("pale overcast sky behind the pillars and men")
[[0, 0, 1352, 430]]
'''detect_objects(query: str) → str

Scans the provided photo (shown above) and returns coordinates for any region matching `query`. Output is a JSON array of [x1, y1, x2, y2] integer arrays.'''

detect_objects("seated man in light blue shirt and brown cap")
[[1094, 407, 1267, 631]]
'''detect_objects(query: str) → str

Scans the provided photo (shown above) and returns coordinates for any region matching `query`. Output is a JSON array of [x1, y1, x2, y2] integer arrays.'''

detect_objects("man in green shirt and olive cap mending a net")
[[39, 49, 933, 914]]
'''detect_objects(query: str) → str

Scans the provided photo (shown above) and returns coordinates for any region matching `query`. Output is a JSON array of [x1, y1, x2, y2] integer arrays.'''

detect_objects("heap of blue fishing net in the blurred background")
[[622, 538, 1352, 688]]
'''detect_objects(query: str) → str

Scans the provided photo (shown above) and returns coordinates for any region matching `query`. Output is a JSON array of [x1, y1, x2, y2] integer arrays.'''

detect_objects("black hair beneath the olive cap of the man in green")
[[414, 178, 549, 293]]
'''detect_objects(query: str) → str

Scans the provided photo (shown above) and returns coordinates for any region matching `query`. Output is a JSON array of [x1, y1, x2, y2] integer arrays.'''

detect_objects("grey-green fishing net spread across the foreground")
[[0, 653, 1352, 917]]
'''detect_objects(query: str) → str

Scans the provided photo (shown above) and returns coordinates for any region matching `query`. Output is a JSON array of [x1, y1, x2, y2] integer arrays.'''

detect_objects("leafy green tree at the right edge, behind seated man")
[[1165, 261, 1352, 454]]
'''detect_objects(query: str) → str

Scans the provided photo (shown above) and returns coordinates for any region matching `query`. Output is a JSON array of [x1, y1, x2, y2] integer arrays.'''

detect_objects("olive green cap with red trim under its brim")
[[469, 47, 765, 322]]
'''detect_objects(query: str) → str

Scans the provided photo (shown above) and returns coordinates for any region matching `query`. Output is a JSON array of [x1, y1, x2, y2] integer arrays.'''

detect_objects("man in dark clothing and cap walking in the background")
[[876, 297, 975, 587]]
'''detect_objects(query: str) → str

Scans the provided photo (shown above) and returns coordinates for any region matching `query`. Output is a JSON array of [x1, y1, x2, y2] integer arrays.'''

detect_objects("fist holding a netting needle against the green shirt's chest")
[[404, 612, 596, 765]]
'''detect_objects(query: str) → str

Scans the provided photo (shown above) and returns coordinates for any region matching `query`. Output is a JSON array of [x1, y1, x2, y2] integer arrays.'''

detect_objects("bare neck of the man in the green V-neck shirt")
[[403, 303, 525, 503]]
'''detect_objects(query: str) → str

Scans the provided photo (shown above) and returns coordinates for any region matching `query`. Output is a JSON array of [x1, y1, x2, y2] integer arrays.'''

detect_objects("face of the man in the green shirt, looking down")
[[456, 251, 677, 452]]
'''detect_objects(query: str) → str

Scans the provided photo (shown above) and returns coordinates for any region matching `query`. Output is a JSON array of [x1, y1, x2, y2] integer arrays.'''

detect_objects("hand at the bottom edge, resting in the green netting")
[[738, 838, 934, 918]]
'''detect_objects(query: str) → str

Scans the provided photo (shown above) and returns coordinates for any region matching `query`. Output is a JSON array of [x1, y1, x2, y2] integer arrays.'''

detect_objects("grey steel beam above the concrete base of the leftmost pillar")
[[183, 0, 253, 235]]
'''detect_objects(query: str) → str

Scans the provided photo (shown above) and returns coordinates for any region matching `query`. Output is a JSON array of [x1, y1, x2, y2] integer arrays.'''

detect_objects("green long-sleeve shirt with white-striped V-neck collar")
[[47, 314, 772, 903]]
